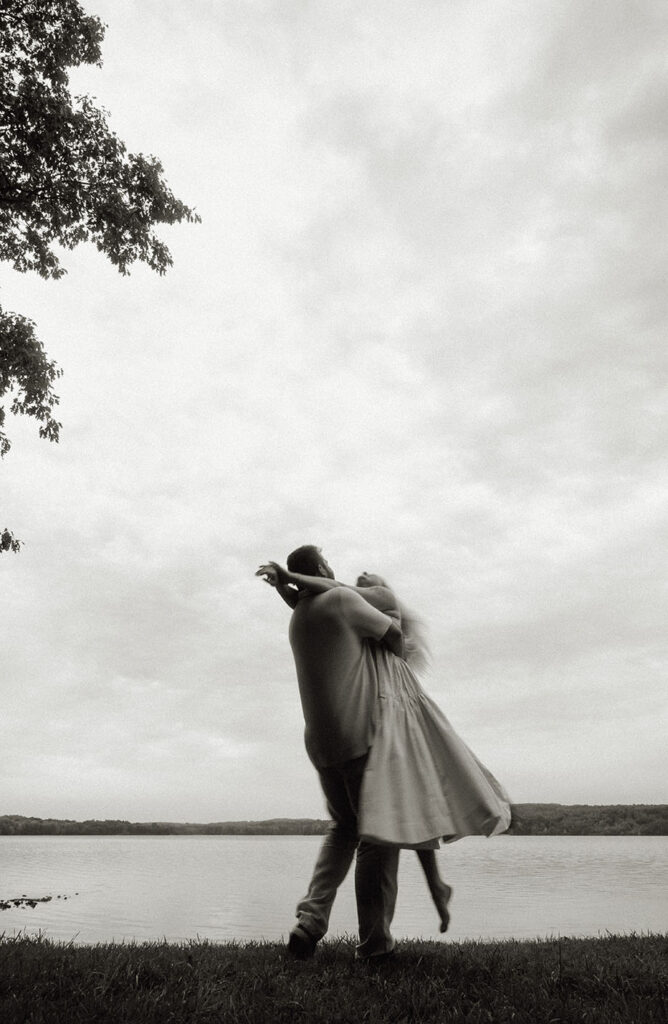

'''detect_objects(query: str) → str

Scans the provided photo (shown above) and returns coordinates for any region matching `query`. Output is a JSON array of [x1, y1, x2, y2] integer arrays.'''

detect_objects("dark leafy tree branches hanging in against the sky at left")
[[0, 0, 200, 551]]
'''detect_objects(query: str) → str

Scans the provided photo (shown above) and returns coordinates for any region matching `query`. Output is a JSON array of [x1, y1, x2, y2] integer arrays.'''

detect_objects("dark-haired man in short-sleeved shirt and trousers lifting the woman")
[[260, 545, 402, 959]]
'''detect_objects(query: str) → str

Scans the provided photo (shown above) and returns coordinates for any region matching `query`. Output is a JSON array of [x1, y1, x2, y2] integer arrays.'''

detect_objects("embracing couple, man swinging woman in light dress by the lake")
[[256, 545, 510, 961]]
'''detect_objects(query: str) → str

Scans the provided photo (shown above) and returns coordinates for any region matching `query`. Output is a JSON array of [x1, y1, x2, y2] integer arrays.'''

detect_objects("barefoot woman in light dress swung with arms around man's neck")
[[256, 562, 510, 932]]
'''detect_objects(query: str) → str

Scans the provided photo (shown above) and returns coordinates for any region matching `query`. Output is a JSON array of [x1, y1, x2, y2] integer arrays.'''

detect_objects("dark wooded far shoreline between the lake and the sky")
[[0, 804, 668, 836]]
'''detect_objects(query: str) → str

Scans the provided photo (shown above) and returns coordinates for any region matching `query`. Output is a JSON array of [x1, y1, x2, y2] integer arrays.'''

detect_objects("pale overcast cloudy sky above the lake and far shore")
[[0, 0, 668, 821]]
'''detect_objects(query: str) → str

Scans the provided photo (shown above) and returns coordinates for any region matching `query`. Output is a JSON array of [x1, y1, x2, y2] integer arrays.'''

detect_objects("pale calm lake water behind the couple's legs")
[[0, 836, 668, 943]]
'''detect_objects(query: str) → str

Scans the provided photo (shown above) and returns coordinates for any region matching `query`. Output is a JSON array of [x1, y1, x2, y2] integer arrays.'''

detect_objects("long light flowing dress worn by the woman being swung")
[[360, 644, 510, 849]]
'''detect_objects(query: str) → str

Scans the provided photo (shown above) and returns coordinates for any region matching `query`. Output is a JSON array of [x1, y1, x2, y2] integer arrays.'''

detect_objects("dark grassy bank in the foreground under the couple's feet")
[[0, 936, 668, 1024]]
